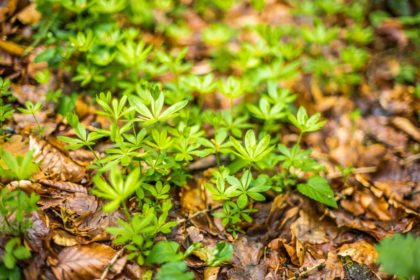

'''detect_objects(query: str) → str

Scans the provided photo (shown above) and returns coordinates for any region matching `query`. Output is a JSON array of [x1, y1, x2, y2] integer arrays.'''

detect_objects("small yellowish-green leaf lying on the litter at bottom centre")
[[147, 241, 183, 264]]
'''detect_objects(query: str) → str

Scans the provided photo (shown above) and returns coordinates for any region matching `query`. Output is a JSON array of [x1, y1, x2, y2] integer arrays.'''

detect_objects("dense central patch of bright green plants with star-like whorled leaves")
[[30, 0, 374, 279]]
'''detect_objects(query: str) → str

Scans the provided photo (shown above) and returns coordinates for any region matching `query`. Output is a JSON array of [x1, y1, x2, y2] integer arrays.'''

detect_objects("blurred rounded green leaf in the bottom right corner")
[[376, 234, 420, 279]]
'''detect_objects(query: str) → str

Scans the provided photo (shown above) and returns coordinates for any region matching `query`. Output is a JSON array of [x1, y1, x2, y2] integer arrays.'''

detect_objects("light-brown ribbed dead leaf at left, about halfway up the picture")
[[29, 136, 86, 183]]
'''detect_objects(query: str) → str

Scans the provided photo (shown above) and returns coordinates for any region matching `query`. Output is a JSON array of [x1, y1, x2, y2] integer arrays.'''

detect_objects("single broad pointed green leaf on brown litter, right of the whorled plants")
[[297, 176, 338, 208]]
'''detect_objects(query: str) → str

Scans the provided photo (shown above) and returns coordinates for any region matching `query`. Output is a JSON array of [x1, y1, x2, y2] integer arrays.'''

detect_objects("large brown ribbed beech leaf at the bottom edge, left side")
[[52, 243, 125, 280]]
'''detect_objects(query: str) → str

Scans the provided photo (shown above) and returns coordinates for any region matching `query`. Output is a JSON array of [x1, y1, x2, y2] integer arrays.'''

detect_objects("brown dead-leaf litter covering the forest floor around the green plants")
[[0, 1, 420, 279]]
